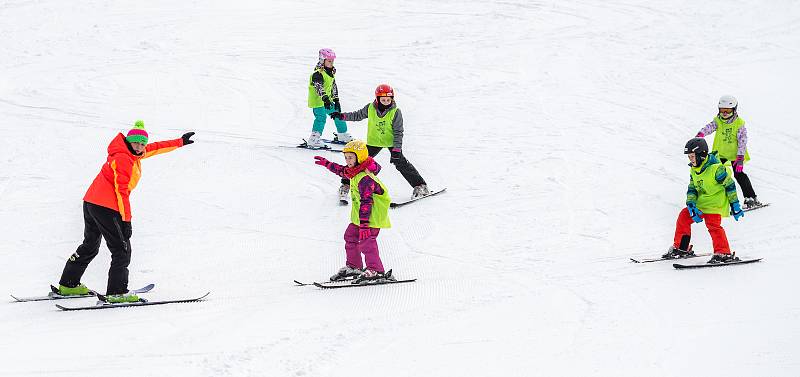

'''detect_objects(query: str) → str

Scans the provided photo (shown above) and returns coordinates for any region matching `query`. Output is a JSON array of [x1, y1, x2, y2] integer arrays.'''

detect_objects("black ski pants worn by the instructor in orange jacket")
[[59, 202, 132, 295]]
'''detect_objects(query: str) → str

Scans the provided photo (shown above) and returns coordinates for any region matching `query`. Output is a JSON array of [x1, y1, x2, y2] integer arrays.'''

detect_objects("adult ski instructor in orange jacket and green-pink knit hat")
[[59, 120, 194, 302]]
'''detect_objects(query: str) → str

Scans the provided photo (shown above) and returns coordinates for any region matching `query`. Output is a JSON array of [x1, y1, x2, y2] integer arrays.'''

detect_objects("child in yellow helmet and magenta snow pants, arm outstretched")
[[314, 140, 391, 282]]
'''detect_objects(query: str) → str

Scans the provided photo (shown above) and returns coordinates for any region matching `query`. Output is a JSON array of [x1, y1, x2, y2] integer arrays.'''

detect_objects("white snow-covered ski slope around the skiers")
[[0, 0, 800, 377]]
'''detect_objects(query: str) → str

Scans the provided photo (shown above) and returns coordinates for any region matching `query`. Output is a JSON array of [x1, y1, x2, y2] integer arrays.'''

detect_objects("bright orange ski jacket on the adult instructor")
[[83, 133, 183, 221]]
